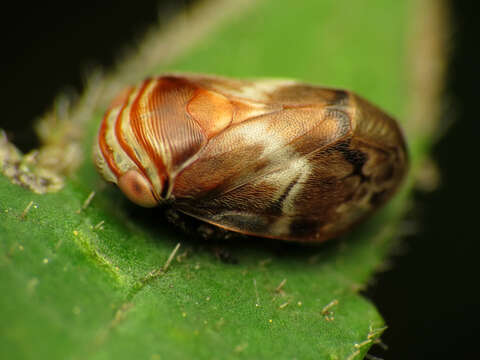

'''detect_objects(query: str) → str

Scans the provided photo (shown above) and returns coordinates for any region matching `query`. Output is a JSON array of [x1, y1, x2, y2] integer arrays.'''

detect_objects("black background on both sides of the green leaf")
[[0, 0, 480, 360]]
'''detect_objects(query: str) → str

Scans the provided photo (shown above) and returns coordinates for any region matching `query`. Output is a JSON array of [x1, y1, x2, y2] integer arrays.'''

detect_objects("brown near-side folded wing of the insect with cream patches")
[[173, 80, 406, 241]]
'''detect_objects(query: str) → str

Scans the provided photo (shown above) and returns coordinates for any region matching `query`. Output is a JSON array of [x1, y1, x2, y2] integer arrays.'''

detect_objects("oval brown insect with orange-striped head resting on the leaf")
[[94, 74, 408, 242]]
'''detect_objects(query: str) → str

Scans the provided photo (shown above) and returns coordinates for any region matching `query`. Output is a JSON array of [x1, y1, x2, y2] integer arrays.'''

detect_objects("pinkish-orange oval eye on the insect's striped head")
[[118, 169, 158, 207]]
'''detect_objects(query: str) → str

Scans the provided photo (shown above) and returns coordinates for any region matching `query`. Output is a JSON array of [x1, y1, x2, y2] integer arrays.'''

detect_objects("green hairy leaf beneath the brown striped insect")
[[0, 0, 444, 359]]
